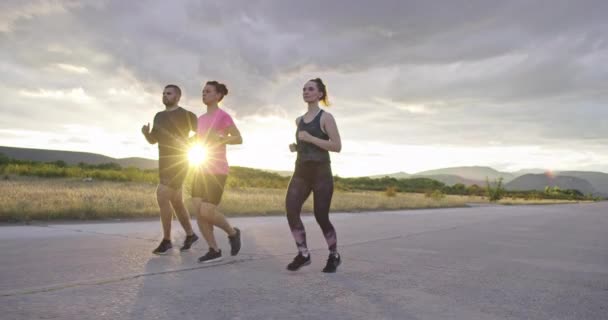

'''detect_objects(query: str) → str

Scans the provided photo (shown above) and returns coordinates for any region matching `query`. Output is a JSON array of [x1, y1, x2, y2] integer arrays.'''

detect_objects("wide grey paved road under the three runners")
[[0, 203, 608, 320]]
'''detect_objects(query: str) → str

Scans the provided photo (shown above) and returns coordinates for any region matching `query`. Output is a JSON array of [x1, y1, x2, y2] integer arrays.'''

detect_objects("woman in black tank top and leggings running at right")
[[285, 78, 342, 272]]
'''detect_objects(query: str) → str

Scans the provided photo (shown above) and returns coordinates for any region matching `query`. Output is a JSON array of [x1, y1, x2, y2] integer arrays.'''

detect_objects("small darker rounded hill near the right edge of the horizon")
[[505, 174, 598, 194]]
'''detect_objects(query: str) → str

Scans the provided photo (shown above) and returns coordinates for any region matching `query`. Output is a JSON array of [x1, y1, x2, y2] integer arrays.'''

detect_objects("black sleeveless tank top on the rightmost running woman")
[[296, 110, 330, 163]]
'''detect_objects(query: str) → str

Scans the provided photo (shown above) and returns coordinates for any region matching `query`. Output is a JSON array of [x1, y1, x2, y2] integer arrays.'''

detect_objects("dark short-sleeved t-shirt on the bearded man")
[[151, 107, 197, 185]]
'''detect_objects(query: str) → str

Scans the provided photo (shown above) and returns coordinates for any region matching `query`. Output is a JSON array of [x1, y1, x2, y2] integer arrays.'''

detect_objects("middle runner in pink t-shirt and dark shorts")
[[192, 81, 243, 263]]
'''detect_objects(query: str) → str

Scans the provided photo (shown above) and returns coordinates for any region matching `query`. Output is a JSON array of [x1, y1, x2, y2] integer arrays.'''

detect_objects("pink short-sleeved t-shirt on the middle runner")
[[196, 109, 234, 175]]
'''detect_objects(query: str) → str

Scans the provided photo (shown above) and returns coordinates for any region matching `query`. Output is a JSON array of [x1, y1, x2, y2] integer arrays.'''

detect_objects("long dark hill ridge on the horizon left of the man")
[[0, 146, 158, 169]]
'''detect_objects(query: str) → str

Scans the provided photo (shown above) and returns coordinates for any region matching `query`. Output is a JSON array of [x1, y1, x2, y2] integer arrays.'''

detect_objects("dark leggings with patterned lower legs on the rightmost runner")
[[285, 162, 338, 255]]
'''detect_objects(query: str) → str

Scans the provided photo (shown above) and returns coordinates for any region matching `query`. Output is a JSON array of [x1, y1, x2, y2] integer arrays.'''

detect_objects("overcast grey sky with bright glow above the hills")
[[0, 0, 608, 176]]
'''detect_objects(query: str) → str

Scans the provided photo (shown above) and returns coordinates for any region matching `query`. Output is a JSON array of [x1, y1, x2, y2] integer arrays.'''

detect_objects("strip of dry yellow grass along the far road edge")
[[0, 177, 588, 221]]
